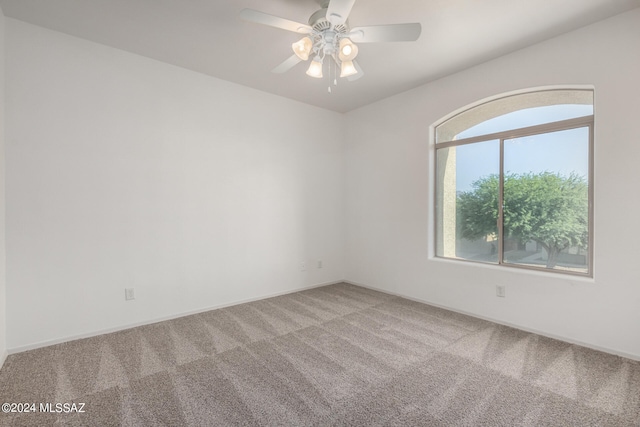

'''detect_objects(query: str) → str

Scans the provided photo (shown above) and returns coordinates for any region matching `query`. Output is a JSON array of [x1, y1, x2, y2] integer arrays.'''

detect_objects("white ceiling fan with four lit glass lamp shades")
[[240, 0, 422, 81]]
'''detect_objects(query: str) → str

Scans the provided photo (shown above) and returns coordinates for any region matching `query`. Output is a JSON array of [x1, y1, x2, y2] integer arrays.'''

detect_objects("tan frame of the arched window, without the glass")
[[431, 87, 595, 278]]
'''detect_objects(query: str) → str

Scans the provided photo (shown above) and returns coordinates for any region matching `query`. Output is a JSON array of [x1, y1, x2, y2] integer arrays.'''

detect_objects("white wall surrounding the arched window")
[[345, 9, 640, 359]]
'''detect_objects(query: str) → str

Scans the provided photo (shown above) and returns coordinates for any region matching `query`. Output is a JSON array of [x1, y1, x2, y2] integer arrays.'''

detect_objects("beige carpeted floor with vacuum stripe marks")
[[0, 284, 640, 427]]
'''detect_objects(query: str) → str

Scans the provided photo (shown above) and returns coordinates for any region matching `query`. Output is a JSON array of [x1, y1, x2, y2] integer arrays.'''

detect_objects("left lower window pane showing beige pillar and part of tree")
[[436, 140, 500, 263]]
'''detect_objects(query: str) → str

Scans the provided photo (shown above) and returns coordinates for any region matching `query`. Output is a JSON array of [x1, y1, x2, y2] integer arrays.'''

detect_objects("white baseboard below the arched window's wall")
[[344, 280, 640, 361]]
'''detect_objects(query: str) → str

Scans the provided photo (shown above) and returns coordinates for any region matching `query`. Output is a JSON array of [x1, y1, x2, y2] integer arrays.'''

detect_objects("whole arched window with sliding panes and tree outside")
[[435, 89, 594, 276]]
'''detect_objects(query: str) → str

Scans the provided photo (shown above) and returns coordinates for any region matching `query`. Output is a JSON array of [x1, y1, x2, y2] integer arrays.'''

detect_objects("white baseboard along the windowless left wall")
[[7, 280, 344, 356]]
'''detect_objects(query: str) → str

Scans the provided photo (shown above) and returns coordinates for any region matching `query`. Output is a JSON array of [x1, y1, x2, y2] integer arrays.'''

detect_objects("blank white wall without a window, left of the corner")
[[6, 19, 344, 351]]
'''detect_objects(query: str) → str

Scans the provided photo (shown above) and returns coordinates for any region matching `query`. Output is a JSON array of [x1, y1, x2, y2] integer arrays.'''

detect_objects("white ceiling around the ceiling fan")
[[0, 0, 640, 112]]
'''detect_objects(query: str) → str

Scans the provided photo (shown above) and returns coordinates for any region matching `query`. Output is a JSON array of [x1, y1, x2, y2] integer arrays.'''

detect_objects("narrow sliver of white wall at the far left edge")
[[0, 5, 7, 367]]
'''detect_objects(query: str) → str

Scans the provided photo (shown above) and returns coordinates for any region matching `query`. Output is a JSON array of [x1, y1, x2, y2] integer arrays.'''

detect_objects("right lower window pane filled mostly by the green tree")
[[503, 127, 589, 273]]
